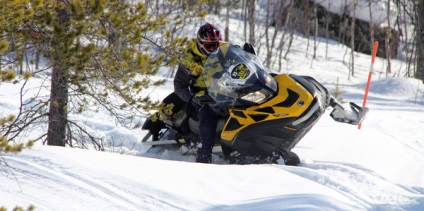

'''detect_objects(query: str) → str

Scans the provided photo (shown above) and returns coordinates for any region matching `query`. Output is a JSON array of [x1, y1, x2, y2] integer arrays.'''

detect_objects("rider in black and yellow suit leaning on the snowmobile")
[[174, 23, 222, 163]]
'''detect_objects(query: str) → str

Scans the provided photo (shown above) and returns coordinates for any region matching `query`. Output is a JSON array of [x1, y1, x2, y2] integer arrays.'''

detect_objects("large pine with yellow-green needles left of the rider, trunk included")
[[0, 0, 205, 149]]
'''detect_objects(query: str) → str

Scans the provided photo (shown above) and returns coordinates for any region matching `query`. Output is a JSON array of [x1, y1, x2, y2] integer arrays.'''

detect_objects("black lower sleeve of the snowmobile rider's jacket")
[[174, 65, 193, 102]]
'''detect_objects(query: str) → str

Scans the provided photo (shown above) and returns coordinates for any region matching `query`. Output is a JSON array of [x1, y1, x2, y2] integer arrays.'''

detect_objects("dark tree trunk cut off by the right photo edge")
[[415, 0, 424, 82]]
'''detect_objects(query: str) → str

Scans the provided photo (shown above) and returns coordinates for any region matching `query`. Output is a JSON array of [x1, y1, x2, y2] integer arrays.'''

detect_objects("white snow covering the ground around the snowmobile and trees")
[[0, 2, 424, 210]]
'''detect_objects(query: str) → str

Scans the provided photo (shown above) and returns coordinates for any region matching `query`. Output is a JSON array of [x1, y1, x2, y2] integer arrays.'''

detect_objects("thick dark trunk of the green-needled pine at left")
[[47, 0, 70, 146]]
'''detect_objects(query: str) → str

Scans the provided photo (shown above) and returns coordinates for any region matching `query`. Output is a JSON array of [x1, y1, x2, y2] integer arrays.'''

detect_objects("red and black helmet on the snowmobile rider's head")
[[197, 23, 222, 55]]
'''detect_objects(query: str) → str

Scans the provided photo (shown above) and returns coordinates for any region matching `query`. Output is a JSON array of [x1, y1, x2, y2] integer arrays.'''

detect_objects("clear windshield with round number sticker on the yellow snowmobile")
[[203, 44, 277, 105]]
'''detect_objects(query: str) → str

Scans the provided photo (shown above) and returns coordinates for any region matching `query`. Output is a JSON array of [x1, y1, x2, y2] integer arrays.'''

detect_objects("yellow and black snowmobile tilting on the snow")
[[142, 44, 368, 165]]
